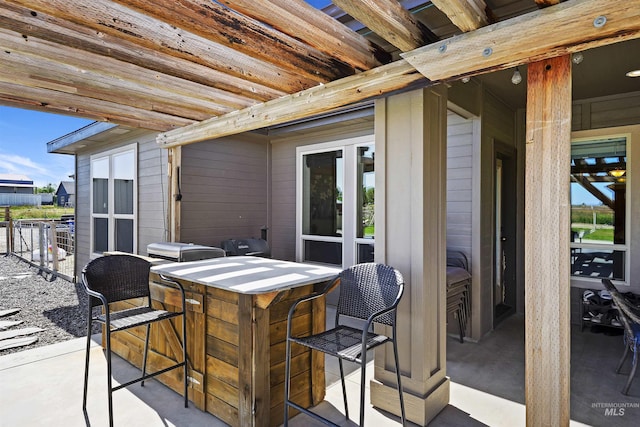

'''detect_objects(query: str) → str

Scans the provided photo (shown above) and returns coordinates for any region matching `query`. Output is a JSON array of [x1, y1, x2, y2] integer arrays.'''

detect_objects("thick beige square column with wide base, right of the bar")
[[371, 85, 449, 425]]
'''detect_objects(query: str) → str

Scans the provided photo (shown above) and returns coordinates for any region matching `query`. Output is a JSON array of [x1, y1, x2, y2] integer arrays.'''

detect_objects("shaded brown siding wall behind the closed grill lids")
[[180, 134, 272, 246]]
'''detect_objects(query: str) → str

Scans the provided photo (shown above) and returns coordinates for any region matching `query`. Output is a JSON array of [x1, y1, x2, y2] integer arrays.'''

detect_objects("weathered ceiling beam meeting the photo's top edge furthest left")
[[9, 0, 318, 93]]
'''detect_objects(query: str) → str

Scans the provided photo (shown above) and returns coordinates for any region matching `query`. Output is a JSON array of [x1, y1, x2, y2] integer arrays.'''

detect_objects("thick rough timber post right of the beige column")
[[525, 55, 571, 426]]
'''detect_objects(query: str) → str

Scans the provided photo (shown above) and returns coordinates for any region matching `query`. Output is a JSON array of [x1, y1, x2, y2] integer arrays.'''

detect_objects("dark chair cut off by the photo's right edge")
[[602, 279, 640, 395]]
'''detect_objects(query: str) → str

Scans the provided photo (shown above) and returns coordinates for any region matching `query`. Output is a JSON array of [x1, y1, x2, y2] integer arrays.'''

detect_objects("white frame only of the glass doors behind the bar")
[[296, 135, 375, 267]]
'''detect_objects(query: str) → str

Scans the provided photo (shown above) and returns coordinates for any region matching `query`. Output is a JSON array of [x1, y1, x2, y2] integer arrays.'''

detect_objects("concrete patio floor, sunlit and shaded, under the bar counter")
[[0, 315, 640, 427]]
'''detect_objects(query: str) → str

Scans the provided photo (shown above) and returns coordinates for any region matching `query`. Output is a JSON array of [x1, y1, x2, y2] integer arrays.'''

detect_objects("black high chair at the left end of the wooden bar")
[[82, 255, 188, 426]]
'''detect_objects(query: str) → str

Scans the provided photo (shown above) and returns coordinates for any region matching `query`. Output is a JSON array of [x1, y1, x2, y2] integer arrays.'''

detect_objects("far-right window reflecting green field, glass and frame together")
[[571, 134, 631, 282]]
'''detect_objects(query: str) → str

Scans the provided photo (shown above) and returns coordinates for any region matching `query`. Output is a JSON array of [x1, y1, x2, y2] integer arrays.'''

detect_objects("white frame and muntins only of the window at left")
[[89, 143, 138, 258]]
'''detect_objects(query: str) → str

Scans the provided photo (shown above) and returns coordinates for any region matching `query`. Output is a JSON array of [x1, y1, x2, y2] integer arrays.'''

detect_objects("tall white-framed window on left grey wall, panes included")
[[90, 144, 138, 254]]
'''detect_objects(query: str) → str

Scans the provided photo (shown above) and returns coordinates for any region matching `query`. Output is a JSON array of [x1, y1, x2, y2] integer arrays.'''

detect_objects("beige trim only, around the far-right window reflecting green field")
[[571, 129, 633, 286]]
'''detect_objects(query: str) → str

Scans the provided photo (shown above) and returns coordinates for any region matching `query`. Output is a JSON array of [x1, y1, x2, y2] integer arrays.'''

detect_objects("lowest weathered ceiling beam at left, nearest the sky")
[[0, 81, 193, 132]]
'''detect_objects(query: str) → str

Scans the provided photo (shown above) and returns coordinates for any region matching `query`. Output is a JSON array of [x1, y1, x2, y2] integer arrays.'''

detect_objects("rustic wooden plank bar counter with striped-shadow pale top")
[[112, 257, 339, 426]]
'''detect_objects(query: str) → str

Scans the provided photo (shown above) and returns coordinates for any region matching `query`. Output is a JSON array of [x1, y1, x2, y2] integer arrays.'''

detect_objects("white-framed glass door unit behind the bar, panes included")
[[296, 135, 375, 267]]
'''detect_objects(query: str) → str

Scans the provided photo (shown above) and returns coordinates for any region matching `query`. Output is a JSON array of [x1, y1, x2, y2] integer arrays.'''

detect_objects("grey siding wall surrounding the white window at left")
[[75, 130, 168, 277]]
